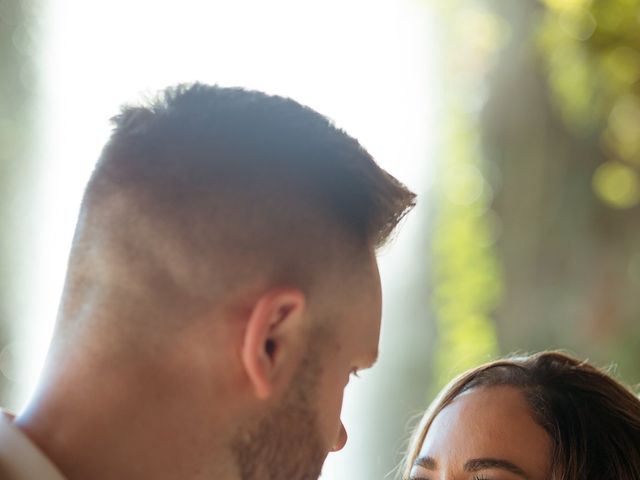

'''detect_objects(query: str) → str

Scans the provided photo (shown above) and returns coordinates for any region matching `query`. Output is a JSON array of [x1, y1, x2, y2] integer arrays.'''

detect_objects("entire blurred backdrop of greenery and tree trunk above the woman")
[[432, 0, 640, 388]]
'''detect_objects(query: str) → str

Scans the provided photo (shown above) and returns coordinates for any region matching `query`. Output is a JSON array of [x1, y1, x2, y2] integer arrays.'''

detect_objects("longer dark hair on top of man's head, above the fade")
[[94, 83, 415, 245]]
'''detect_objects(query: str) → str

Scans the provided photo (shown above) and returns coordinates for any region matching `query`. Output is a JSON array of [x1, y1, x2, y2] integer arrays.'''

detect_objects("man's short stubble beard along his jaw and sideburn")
[[233, 348, 328, 480]]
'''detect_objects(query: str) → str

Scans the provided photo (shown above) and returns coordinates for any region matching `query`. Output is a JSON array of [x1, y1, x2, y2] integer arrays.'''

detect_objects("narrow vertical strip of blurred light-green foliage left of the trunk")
[[432, 1, 504, 388]]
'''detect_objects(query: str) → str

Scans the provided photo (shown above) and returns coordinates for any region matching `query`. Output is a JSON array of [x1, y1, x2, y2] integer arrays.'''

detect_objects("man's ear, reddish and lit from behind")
[[242, 288, 305, 399]]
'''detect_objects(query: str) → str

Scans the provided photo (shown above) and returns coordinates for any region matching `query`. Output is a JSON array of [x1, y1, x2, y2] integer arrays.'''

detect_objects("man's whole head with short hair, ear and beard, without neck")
[[37, 84, 414, 479]]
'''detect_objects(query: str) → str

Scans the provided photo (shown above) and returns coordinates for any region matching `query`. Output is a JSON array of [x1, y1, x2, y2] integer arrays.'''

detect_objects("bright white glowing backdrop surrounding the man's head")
[[13, 0, 437, 480]]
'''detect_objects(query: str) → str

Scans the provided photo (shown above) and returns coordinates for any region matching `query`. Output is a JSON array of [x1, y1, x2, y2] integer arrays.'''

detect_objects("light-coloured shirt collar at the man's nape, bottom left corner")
[[0, 412, 65, 480]]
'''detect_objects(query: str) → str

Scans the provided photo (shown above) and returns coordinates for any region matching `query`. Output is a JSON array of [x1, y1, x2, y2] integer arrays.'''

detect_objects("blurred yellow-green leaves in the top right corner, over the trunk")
[[539, 0, 640, 209]]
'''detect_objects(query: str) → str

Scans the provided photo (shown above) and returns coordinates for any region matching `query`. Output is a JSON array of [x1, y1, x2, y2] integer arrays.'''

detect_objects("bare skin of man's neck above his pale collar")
[[15, 352, 238, 480]]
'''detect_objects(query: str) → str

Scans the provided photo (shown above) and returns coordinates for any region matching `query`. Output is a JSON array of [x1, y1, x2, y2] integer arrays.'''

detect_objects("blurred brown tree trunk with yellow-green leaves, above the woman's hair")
[[482, 0, 640, 382]]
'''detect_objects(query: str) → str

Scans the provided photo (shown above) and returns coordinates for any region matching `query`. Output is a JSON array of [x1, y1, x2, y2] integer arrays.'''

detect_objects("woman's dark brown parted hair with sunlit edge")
[[404, 352, 640, 480]]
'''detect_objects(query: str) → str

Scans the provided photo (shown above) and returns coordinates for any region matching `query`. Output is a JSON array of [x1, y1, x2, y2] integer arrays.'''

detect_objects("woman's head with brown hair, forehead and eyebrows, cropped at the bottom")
[[404, 352, 640, 480]]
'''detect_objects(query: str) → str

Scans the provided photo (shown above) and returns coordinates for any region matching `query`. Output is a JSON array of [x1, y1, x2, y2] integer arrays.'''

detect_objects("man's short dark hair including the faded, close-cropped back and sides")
[[63, 83, 415, 322]]
